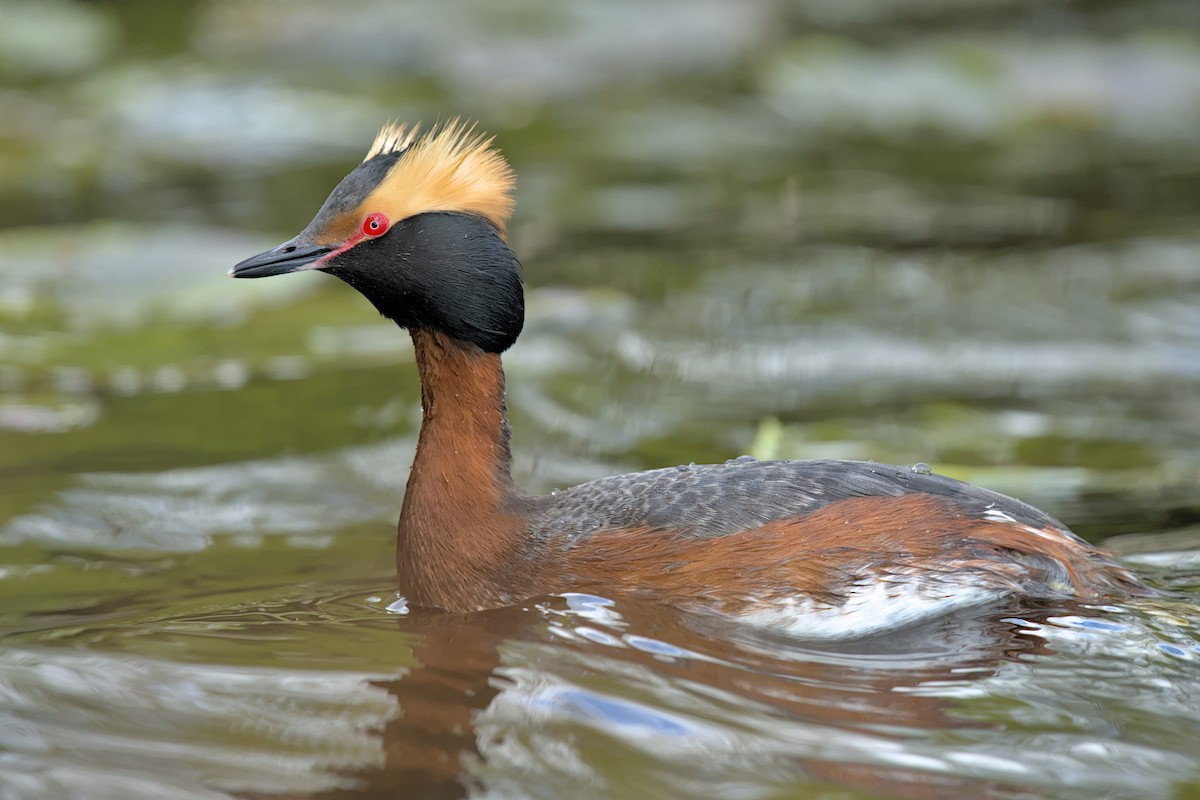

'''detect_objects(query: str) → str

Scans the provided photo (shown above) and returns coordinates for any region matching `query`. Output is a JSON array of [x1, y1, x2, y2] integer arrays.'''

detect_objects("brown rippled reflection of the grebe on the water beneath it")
[[234, 599, 1070, 800]]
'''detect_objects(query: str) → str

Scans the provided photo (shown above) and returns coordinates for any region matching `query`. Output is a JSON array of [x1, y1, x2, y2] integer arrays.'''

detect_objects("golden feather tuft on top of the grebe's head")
[[361, 119, 516, 235]]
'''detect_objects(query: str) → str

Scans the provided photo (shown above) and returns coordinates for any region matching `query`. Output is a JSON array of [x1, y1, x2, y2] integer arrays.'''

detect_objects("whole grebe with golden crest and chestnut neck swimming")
[[229, 121, 1146, 636]]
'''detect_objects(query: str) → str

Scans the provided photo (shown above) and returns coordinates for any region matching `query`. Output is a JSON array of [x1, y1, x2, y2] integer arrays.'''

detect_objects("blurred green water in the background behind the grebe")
[[0, 0, 1200, 541]]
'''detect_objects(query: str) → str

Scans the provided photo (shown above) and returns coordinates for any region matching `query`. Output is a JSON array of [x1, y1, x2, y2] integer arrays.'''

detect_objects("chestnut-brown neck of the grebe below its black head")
[[396, 327, 527, 609]]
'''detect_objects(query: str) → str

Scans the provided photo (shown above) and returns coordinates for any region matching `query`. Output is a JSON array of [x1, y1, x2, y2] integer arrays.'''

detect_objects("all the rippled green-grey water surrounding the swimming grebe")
[[0, 0, 1200, 800]]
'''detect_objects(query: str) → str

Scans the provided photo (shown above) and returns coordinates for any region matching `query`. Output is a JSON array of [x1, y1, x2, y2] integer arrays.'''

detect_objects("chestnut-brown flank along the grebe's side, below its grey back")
[[564, 493, 1139, 613]]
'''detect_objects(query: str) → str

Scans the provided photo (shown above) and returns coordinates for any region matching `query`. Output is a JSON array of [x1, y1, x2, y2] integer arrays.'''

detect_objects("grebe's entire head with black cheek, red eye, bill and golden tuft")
[[229, 124, 524, 353]]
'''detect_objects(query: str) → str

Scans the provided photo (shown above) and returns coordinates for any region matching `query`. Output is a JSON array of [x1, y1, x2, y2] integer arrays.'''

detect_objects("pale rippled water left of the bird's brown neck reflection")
[[0, 648, 398, 800]]
